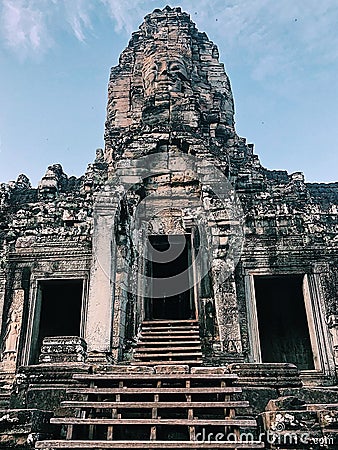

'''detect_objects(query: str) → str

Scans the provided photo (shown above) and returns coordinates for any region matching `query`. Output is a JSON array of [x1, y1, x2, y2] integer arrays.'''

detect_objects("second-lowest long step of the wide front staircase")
[[50, 417, 257, 428]]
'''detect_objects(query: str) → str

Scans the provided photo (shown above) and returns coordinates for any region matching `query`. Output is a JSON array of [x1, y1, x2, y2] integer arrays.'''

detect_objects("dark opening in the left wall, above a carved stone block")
[[33, 280, 83, 361]]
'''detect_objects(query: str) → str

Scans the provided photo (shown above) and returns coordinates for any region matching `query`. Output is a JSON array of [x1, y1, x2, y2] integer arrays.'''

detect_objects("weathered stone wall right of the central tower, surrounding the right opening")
[[234, 147, 338, 374]]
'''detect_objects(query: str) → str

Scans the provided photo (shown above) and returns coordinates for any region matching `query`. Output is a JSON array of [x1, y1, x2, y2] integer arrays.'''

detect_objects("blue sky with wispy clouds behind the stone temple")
[[0, 0, 338, 185]]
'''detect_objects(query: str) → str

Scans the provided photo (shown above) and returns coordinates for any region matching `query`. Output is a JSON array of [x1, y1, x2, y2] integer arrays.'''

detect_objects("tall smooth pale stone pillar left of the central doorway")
[[85, 192, 118, 362]]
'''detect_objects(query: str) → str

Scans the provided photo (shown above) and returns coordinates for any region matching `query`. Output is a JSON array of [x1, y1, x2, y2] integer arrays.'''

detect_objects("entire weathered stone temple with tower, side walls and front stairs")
[[0, 7, 338, 450]]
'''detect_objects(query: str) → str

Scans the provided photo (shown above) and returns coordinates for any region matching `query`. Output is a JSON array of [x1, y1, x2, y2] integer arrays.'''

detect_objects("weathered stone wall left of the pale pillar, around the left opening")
[[0, 158, 107, 373]]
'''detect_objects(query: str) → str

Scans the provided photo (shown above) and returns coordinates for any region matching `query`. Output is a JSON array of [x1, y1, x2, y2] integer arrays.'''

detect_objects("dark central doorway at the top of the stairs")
[[145, 235, 195, 320]]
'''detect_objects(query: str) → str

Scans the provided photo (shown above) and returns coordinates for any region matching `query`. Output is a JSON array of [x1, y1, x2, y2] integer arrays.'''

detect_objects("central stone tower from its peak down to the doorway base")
[[87, 5, 243, 361]]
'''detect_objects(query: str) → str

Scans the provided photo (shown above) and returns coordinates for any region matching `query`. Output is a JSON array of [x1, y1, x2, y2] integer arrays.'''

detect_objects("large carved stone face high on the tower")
[[142, 55, 190, 96]]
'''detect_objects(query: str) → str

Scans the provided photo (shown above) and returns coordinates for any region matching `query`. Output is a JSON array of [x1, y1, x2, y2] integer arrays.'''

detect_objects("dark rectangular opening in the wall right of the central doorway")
[[254, 275, 314, 370]]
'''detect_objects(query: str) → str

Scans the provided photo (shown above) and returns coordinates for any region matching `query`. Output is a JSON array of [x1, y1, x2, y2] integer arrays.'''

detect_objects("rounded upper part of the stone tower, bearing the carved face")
[[105, 5, 234, 158]]
